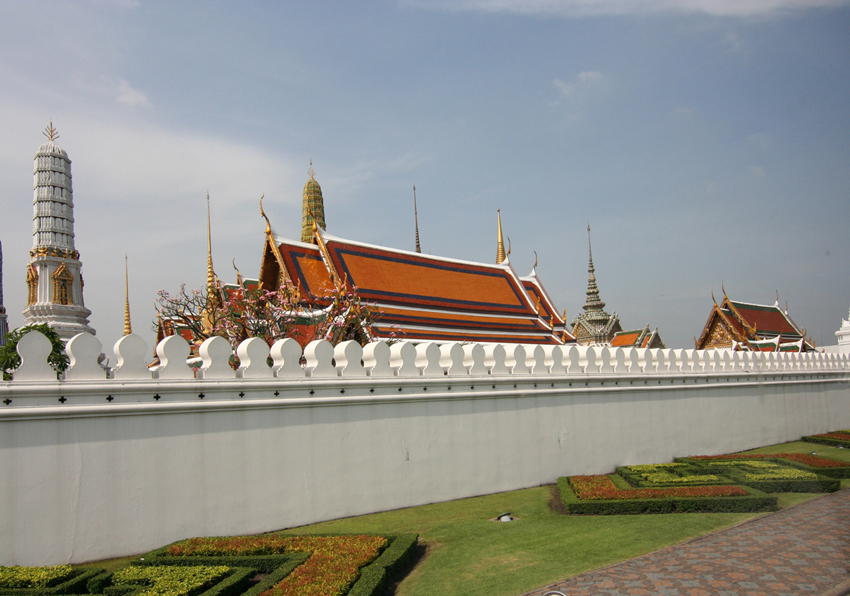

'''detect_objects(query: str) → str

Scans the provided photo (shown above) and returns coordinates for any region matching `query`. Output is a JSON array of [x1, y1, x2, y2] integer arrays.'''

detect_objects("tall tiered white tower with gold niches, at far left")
[[23, 122, 95, 340]]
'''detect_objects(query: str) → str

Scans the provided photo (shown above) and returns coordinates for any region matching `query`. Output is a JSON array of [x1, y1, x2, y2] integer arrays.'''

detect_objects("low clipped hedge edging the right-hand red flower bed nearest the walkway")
[[558, 475, 777, 515]]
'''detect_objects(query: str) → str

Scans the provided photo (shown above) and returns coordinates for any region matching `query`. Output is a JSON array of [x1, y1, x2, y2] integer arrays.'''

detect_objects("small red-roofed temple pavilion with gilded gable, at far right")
[[695, 289, 814, 352]]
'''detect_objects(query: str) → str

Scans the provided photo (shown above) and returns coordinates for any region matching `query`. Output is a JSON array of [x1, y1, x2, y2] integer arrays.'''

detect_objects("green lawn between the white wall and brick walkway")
[[287, 442, 850, 596]]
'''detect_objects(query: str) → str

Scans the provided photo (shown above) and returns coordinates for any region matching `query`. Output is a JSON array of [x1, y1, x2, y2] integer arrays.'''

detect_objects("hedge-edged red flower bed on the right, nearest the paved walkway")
[[558, 475, 776, 515]]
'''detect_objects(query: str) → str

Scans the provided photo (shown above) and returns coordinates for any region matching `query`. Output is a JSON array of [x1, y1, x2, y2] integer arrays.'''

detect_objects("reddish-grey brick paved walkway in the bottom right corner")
[[523, 489, 850, 596]]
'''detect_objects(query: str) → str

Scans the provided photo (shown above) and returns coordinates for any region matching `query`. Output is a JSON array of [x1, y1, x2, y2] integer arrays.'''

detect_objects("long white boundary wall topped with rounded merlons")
[[0, 334, 850, 565]]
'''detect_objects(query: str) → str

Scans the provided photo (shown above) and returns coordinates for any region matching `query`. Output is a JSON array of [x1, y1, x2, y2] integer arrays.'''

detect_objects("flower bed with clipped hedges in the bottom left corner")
[[0, 534, 417, 596]]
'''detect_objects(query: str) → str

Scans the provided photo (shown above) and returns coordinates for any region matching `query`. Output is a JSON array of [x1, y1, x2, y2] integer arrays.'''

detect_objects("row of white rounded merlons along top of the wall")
[[6, 333, 850, 381]]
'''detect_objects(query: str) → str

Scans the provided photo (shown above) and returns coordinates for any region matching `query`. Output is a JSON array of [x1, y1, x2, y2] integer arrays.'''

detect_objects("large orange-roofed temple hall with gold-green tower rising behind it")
[[252, 165, 574, 344]]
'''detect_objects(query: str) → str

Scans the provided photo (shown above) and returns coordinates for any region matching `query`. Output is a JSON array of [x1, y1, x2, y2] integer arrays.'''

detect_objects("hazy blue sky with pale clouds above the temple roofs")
[[0, 0, 850, 351]]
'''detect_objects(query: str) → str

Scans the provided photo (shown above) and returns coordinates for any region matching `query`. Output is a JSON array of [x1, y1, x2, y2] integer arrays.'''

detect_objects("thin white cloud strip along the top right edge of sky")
[[410, 0, 850, 17]]
